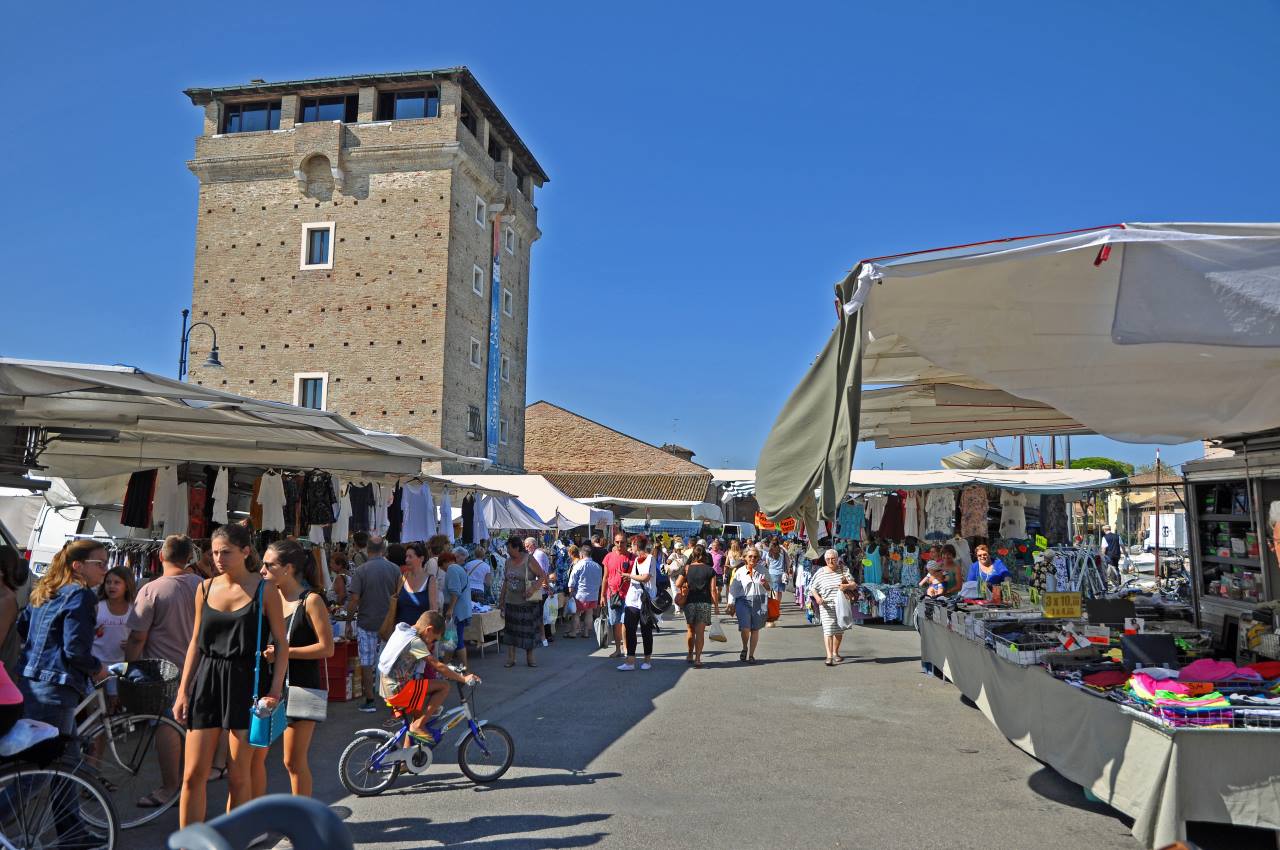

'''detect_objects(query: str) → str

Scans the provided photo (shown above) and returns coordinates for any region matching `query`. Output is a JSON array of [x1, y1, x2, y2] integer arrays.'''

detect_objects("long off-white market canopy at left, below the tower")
[[0, 357, 486, 479]]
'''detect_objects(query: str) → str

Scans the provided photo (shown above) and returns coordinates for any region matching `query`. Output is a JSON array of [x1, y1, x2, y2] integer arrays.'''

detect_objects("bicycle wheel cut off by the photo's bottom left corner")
[[0, 766, 120, 850]]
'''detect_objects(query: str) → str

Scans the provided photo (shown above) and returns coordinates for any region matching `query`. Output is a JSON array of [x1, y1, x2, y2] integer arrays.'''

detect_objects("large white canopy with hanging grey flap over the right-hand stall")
[[756, 224, 1280, 520]]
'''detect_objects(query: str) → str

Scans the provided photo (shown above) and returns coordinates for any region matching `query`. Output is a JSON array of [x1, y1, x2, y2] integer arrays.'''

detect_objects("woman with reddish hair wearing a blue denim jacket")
[[18, 540, 108, 734]]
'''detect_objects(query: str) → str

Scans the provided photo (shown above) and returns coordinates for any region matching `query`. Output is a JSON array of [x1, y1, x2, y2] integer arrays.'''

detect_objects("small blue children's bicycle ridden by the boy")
[[338, 667, 516, 796]]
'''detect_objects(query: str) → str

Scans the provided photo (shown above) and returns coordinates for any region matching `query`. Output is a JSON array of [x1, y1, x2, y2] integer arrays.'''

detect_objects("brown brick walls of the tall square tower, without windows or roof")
[[188, 72, 540, 469]]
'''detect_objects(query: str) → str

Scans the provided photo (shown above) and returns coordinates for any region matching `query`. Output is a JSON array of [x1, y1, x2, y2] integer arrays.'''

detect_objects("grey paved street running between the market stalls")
[[137, 608, 1269, 850]]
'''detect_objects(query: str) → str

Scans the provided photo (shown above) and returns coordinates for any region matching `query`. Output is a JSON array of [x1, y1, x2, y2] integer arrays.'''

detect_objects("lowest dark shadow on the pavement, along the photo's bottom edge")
[[347, 814, 612, 850]]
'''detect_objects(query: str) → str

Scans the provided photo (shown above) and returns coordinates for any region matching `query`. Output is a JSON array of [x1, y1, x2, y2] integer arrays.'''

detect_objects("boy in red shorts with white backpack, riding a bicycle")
[[378, 611, 480, 746]]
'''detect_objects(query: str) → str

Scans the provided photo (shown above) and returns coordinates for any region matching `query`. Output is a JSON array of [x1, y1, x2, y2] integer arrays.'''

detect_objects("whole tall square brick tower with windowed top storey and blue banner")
[[186, 68, 548, 471]]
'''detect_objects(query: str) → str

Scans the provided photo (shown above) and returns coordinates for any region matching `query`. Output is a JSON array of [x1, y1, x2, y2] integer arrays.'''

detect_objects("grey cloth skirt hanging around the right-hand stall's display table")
[[919, 621, 1280, 847]]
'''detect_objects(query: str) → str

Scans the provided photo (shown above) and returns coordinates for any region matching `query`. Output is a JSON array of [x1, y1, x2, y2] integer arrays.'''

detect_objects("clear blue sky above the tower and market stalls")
[[0, 0, 1280, 469]]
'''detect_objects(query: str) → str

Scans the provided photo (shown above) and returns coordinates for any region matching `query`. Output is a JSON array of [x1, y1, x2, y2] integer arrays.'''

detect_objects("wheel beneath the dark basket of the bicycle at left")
[[83, 714, 187, 830]]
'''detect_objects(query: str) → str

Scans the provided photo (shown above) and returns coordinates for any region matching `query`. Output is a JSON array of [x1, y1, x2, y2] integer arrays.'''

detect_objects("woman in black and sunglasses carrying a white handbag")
[[253, 540, 333, 796]]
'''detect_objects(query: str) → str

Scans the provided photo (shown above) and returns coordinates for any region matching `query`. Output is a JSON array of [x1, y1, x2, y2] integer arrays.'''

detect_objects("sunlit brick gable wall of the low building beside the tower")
[[525, 402, 709, 480]]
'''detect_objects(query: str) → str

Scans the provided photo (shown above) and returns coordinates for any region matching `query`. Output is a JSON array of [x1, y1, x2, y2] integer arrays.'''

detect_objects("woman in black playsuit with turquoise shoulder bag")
[[173, 525, 288, 827]]
